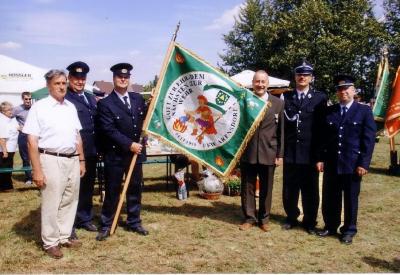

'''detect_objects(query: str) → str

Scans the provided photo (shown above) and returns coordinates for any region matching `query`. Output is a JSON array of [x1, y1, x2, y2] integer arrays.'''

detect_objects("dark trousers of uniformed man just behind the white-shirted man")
[[74, 157, 96, 227]]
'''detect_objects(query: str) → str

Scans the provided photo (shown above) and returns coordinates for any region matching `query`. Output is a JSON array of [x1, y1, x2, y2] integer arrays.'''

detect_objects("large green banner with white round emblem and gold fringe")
[[144, 42, 271, 176]]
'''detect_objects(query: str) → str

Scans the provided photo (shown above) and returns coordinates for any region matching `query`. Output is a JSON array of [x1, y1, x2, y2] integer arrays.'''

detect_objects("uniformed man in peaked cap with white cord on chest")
[[282, 60, 327, 234]]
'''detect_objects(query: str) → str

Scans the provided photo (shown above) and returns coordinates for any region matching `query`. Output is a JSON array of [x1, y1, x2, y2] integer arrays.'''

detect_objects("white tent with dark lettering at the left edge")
[[0, 54, 93, 106]]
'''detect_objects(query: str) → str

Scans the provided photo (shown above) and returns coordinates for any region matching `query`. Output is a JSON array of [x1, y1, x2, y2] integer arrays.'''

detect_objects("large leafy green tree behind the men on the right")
[[220, 0, 385, 99]]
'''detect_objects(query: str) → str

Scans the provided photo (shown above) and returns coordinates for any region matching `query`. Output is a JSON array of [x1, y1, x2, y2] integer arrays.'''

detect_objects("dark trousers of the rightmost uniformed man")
[[322, 165, 361, 236]]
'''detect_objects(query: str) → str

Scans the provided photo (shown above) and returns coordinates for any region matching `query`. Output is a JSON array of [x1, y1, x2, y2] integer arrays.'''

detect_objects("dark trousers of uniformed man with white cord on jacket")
[[282, 163, 319, 228]]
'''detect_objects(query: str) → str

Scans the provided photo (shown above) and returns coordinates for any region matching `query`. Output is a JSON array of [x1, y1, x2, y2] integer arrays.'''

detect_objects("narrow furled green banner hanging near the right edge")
[[372, 58, 391, 122]]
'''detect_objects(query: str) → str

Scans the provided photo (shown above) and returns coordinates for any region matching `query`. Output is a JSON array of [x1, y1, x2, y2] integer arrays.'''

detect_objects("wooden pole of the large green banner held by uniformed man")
[[110, 22, 181, 235]]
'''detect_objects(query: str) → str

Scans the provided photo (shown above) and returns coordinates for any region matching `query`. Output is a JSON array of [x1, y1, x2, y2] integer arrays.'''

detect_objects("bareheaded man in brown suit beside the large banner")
[[239, 70, 284, 232]]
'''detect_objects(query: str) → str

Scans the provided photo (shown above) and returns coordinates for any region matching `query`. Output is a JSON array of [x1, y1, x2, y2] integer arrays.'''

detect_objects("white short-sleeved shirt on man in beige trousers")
[[22, 95, 82, 154]]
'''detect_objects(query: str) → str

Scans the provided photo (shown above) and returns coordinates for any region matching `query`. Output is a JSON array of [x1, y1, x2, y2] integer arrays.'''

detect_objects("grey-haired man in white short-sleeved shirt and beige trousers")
[[23, 70, 85, 259]]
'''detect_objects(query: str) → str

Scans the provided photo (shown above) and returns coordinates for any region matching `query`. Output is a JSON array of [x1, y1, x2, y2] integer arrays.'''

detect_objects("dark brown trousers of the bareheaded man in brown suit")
[[240, 162, 275, 224]]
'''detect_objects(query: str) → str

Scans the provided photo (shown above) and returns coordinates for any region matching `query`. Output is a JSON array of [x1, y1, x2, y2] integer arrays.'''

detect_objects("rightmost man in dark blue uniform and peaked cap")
[[317, 75, 376, 244]]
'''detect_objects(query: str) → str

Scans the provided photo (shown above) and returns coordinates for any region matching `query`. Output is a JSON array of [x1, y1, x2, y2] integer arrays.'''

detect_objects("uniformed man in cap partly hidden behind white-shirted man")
[[65, 61, 97, 239]]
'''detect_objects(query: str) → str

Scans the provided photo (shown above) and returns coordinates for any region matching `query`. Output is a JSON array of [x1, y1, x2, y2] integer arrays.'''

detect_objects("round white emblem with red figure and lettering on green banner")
[[163, 71, 240, 150]]
